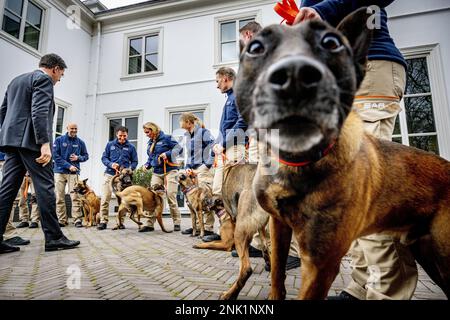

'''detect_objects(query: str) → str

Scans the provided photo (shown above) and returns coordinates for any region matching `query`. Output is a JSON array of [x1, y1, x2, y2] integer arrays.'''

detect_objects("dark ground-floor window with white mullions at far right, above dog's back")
[[393, 56, 439, 154]]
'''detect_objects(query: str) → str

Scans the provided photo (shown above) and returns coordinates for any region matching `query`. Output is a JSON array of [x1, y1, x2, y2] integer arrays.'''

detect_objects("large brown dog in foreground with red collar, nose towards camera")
[[235, 8, 450, 299]]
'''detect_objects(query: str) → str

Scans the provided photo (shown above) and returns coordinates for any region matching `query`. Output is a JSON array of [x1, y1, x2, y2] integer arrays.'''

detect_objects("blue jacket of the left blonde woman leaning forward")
[[145, 131, 183, 174]]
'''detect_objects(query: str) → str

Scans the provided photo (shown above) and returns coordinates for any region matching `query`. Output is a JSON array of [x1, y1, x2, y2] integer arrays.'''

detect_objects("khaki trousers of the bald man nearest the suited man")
[[55, 173, 83, 224]]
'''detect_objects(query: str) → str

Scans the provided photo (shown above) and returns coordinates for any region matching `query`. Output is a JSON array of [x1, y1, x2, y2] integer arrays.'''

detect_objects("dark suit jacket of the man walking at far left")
[[0, 70, 55, 151]]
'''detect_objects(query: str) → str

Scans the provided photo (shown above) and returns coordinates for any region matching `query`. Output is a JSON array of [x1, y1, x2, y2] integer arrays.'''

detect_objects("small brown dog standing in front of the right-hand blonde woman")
[[177, 172, 212, 238]]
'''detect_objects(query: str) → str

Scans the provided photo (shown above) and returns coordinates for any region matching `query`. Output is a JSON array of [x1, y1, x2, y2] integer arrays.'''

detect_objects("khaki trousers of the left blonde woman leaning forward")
[[146, 170, 181, 227]]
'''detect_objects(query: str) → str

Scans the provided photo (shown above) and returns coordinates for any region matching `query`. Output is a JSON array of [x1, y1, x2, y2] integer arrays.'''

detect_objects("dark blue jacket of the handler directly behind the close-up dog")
[[302, 0, 406, 69]]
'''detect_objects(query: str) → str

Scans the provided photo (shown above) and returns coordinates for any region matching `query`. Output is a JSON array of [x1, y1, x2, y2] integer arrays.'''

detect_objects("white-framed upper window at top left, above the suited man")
[[0, 0, 50, 58]]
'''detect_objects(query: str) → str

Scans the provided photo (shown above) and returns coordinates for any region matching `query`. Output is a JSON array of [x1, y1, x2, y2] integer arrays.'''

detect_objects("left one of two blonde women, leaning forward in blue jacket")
[[139, 122, 182, 232]]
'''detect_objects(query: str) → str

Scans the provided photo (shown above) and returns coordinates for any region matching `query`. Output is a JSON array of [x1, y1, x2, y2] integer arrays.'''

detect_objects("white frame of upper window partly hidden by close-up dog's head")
[[213, 10, 261, 69]]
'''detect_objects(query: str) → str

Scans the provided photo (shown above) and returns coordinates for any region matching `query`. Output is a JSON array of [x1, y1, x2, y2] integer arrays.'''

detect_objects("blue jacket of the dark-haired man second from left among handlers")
[[102, 139, 138, 175]]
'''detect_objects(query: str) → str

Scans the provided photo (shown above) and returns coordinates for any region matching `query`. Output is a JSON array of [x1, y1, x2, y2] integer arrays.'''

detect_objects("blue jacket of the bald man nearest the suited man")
[[53, 133, 89, 174]]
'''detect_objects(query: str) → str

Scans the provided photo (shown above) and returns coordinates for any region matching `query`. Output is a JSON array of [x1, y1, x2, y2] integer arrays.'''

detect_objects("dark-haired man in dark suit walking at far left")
[[0, 54, 80, 253]]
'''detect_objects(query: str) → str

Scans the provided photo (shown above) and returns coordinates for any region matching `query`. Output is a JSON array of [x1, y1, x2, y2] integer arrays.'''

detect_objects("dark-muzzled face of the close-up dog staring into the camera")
[[235, 10, 371, 154]]
